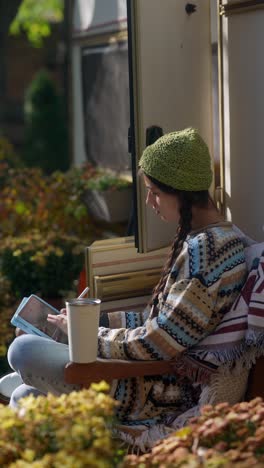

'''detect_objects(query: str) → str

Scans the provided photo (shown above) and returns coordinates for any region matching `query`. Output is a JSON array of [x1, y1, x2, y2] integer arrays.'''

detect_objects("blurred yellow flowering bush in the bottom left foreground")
[[0, 382, 121, 468]]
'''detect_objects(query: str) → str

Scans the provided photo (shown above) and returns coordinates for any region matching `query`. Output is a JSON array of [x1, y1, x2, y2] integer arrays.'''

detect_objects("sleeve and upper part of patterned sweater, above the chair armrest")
[[99, 223, 247, 360]]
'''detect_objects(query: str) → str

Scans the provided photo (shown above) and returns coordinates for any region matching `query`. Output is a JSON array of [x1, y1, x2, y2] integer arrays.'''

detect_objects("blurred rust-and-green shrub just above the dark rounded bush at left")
[[0, 168, 96, 239]]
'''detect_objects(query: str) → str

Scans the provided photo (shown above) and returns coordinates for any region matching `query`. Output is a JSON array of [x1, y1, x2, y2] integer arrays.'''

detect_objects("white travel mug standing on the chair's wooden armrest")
[[66, 299, 101, 363]]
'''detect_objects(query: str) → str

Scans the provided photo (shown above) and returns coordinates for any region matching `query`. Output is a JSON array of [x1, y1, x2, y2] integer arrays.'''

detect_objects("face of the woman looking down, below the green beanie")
[[143, 175, 180, 223]]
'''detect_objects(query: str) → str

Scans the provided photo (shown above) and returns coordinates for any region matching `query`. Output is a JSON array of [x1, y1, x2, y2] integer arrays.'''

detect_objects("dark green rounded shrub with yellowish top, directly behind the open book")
[[0, 230, 84, 298]]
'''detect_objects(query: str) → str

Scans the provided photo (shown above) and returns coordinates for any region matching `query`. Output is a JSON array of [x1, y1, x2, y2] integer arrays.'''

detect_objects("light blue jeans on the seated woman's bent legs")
[[7, 335, 81, 407]]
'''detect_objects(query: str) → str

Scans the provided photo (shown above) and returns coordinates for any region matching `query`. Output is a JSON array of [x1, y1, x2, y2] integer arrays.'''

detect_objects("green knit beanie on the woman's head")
[[139, 128, 212, 191]]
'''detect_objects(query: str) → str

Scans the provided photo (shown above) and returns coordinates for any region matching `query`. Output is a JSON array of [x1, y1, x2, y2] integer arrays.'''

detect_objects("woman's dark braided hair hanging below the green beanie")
[[146, 174, 209, 306]]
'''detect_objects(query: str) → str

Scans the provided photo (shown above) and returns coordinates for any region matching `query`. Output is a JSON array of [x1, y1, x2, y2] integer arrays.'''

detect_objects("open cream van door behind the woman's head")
[[128, 0, 213, 252]]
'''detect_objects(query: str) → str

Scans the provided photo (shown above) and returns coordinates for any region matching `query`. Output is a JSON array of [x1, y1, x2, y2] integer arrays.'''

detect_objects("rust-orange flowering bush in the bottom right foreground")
[[124, 398, 264, 468]]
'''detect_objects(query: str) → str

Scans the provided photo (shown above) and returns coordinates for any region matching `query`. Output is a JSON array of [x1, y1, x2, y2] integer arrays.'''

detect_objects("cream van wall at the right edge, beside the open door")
[[222, 10, 264, 241]]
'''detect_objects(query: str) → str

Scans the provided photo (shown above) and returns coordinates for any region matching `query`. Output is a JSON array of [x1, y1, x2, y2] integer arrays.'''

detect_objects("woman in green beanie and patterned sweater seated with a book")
[[4, 128, 247, 425]]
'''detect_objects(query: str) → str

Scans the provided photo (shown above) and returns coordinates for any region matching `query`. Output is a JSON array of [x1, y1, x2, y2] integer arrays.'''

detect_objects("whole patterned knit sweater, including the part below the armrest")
[[98, 222, 247, 424]]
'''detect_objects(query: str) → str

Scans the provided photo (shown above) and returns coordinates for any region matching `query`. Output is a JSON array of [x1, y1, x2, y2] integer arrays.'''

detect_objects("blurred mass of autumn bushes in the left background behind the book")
[[0, 137, 131, 357]]
